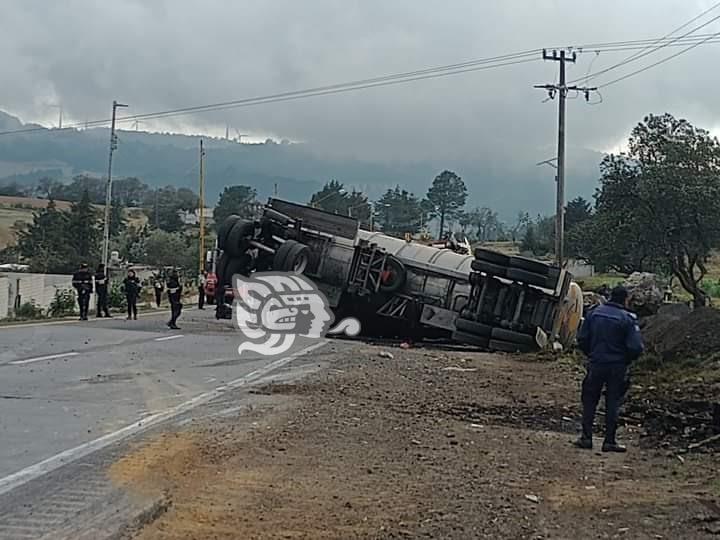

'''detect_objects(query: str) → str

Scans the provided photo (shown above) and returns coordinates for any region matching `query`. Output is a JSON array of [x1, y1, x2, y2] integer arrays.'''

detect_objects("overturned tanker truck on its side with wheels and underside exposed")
[[216, 199, 582, 352]]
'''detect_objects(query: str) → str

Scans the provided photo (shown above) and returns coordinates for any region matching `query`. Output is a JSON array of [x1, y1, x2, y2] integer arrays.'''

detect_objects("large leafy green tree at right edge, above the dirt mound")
[[583, 113, 720, 306]]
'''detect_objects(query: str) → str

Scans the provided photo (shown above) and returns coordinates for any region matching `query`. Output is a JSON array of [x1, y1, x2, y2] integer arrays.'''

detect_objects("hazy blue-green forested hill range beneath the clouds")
[[0, 111, 601, 218]]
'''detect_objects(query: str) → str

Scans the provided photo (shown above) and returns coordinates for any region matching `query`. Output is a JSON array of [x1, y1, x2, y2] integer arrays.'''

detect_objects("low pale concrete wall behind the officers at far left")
[[0, 272, 95, 318]]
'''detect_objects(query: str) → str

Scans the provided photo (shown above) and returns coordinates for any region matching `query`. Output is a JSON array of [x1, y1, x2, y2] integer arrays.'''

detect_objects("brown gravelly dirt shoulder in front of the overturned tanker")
[[109, 345, 720, 540]]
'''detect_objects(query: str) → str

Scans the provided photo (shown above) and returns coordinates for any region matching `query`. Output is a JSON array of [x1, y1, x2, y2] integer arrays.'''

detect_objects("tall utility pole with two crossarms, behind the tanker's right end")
[[535, 49, 597, 268]]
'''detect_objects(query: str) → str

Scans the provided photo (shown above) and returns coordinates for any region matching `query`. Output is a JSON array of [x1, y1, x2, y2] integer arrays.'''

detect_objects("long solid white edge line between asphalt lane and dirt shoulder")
[[0, 340, 327, 495]]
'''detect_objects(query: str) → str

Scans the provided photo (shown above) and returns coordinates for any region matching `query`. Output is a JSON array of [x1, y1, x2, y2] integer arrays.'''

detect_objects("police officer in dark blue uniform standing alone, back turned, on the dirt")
[[575, 286, 643, 452]]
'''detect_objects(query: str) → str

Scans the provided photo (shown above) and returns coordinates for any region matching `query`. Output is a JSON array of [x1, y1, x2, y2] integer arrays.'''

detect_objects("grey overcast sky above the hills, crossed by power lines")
[[0, 0, 720, 165]]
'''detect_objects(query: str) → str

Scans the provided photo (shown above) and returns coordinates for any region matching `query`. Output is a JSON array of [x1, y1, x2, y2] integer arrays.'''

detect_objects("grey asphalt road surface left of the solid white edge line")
[[0, 310, 306, 480]]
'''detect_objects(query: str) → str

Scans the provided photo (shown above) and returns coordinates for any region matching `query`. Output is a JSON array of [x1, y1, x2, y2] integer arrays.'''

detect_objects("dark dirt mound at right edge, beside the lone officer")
[[643, 307, 720, 360]]
